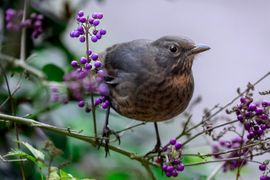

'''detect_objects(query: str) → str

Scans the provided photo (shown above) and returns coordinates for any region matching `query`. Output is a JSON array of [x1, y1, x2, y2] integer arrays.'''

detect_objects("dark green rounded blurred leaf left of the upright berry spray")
[[42, 64, 65, 82]]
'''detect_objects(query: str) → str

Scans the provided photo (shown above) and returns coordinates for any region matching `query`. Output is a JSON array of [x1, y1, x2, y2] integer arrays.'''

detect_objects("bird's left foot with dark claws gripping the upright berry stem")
[[99, 126, 121, 157]]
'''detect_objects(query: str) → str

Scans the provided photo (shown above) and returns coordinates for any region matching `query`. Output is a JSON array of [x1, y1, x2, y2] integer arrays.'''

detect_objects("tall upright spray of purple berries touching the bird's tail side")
[[58, 11, 110, 112]]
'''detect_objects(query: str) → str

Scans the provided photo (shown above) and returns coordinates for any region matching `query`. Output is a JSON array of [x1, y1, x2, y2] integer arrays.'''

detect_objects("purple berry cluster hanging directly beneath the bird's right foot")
[[157, 138, 185, 177]]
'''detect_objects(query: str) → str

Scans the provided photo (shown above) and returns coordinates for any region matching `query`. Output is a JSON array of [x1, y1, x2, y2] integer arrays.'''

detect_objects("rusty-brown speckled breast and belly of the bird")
[[114, 75, 194, 121]]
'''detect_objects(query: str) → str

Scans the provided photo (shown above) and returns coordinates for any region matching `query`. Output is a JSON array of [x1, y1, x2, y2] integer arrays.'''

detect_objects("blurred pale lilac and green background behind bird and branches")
[[0, 0, 270, 179]]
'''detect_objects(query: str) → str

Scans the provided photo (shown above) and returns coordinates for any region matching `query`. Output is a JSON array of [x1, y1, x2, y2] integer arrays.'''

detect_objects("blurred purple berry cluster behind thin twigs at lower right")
[[212, 137, 250, 172]]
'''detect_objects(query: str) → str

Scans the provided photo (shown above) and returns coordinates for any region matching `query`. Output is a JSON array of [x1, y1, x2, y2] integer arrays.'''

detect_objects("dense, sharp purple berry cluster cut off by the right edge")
[[234, 96, 270, 140]]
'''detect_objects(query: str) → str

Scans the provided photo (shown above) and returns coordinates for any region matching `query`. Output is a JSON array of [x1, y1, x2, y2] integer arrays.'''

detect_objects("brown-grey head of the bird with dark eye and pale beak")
[[151, 36, 210, 74]]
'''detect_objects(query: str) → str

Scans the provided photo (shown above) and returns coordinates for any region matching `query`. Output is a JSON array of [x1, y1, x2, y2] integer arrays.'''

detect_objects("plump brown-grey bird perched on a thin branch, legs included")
[[100, 36, 210, 156]]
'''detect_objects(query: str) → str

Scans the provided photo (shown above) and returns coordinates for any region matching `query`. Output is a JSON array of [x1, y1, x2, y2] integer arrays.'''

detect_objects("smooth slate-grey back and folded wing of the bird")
[[104, 40, 154, 84]]
